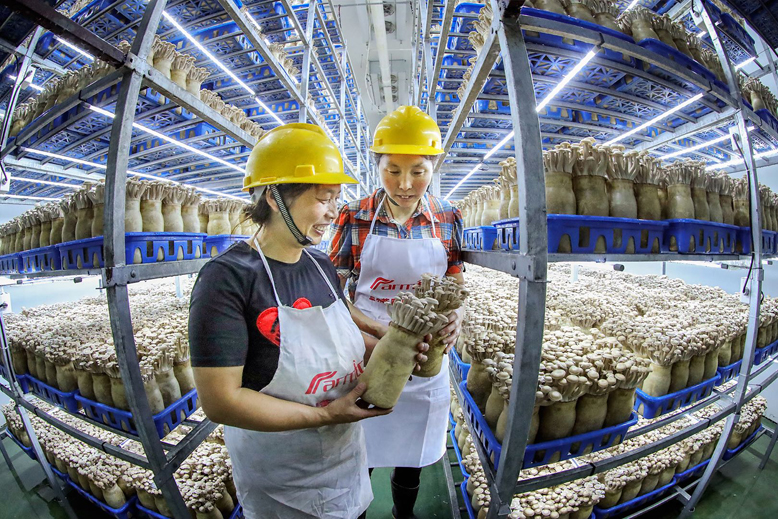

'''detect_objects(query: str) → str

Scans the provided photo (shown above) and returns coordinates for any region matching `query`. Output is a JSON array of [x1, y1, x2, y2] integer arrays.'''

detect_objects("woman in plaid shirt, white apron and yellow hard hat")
[[330, 106, 464, 519]]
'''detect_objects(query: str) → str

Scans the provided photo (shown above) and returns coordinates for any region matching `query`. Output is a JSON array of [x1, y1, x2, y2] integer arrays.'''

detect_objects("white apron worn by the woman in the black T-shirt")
[[224, 239, 373, 519]]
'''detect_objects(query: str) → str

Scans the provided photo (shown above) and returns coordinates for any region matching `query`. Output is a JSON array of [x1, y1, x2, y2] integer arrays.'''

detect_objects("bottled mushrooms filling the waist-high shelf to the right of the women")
[[456, 265, 778, 443]]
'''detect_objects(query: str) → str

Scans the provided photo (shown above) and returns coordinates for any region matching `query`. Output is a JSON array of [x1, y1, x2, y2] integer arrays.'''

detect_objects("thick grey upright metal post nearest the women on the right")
[[488, 0, 548, 519]]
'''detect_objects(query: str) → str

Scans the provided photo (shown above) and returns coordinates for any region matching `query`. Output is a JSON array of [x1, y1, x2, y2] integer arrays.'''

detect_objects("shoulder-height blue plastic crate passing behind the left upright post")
[[56, 232, 206, 269]]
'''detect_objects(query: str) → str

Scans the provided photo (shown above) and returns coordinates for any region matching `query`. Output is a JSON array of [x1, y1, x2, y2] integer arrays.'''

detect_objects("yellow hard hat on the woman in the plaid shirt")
[[370, 106, 445, 155]]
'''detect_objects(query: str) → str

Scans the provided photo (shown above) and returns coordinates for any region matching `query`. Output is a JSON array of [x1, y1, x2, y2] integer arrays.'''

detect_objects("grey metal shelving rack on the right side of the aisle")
[[415, 0, 778, 519]]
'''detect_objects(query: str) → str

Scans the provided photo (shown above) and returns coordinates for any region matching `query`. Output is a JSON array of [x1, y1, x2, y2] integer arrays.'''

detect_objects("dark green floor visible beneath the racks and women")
[[0, 430, 778, 519]]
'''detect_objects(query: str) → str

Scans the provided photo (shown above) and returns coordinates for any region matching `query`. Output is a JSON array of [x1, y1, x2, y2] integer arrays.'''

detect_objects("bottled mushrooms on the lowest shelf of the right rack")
[[451, 391, 767, 519]]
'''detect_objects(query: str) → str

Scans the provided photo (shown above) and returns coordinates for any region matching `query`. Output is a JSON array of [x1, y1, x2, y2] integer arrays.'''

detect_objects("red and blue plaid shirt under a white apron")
[[329, 189, 464, 298]]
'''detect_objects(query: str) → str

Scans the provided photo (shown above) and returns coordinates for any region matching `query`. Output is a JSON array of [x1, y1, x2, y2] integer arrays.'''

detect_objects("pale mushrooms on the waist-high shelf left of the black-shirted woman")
[[5, 282, 194, 422]]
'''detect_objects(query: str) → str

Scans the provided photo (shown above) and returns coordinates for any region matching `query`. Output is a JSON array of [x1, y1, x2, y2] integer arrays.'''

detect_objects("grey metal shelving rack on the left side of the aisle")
[[0, 0, 374, 519]]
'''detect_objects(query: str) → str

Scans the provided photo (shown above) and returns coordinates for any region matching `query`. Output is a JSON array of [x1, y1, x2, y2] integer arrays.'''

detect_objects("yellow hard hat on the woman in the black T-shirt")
[[243, 123, 359, 191]]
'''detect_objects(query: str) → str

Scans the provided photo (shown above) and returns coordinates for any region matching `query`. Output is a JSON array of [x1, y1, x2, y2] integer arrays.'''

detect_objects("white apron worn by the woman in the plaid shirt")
[[354, 197, 450, 468]]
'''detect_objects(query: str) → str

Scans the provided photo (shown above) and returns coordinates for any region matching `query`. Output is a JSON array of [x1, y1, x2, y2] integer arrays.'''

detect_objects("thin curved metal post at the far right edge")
[[679, 0, 764, 519]]
